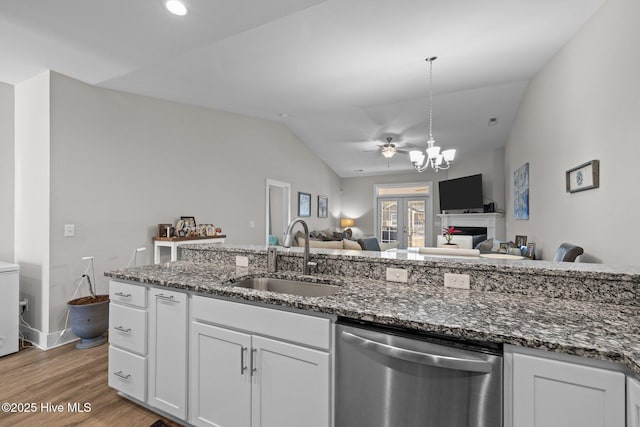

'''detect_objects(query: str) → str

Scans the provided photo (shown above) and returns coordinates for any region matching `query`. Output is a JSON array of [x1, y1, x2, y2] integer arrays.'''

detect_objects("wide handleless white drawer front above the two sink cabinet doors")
[[192, 296, 331, 350]]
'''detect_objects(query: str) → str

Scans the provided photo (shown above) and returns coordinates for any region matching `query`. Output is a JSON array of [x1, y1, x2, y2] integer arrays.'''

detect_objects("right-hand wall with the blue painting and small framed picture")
[[505, 0, 640, 265]]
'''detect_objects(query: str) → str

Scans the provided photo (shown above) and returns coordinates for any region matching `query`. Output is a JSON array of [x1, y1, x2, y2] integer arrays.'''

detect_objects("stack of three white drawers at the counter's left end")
[[109, 280, 147, 401]]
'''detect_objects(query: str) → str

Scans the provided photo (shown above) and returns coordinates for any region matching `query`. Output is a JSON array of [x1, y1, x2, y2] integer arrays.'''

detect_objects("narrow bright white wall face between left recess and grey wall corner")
[[15, 71, 50, 339]]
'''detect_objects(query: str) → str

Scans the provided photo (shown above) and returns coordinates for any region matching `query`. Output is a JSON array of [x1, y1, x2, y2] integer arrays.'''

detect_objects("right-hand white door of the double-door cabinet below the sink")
[[251, 336, 331, 427]]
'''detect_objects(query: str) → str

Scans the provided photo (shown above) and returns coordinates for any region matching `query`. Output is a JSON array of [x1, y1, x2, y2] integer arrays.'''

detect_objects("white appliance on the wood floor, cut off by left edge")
[[0, 262, 20, 356]]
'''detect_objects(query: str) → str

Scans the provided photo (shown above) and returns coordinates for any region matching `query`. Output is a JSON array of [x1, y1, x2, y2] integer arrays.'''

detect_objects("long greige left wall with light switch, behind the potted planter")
[[16, 72, 340, 344]]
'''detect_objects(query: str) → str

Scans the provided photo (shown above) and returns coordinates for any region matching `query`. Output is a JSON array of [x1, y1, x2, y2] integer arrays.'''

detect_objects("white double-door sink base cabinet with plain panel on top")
[[190, 296, 332, 427]]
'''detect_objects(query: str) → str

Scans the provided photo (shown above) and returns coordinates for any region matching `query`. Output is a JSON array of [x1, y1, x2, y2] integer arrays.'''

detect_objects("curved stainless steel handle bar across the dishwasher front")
[[342, 331, 491, 373]]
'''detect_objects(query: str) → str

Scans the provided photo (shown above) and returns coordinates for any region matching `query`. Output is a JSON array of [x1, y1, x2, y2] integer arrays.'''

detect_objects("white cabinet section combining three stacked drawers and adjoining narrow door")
[[109, 280, 188, 419]]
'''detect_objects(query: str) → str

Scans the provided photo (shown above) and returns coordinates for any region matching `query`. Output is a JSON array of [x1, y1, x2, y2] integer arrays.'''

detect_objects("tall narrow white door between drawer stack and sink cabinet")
[[147, 289, 188, 419]]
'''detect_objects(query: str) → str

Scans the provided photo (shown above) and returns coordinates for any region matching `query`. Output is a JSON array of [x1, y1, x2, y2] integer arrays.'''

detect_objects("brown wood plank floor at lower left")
[[0, 343, 177, 427]]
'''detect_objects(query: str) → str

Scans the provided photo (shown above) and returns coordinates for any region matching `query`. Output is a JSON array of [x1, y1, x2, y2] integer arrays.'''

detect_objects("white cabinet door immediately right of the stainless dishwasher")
[[513, 354, 625, 427]]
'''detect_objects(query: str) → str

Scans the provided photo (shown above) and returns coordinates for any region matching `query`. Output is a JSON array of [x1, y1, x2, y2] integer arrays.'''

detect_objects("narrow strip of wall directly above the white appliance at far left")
[[0, 82, 15, 262]]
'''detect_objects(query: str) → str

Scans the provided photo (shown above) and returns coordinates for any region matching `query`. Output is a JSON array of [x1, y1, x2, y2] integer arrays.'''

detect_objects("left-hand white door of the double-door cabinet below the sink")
[[189, 322, 251, 427]]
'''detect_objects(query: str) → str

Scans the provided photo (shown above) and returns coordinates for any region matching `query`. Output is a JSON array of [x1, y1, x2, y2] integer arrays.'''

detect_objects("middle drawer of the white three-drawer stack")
[[109, 303, 147, 355]]
